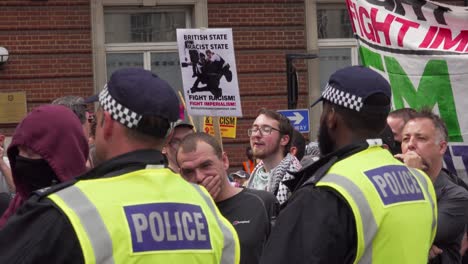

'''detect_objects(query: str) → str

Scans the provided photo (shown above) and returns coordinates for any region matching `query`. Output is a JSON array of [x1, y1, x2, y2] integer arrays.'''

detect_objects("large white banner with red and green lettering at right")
[[347, 0, 468, 180]]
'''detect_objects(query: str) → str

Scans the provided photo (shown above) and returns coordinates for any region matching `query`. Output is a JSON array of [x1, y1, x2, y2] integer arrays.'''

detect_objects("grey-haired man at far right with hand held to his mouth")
[[396, 109, 468, 264]]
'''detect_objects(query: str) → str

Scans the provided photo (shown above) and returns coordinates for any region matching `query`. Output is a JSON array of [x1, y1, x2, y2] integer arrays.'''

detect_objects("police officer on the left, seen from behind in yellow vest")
[[0, 68, 239, 264]]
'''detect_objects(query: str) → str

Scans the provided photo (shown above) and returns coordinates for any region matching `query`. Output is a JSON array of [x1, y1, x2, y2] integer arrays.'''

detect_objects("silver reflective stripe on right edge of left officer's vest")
[[192, 184, 236, 264]]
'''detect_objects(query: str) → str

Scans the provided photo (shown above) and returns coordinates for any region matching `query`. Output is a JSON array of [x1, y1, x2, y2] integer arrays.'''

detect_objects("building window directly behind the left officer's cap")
[[104, 7, 192, 92]]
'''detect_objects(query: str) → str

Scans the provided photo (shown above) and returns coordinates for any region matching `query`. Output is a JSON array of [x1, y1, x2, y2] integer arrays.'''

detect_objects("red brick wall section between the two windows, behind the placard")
[[208, 0, 307, 170]]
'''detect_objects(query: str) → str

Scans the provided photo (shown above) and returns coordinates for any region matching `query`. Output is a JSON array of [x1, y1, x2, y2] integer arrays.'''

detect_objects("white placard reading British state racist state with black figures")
[[177, 28, 242, 116]]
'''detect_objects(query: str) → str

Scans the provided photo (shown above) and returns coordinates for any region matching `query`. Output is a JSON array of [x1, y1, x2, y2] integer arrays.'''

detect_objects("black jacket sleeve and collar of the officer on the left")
[[0, 150, 165, 264]]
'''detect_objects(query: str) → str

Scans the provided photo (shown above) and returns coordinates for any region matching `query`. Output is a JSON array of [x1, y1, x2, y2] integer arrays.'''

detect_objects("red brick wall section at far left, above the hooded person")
[[0, 0, 93, 135]]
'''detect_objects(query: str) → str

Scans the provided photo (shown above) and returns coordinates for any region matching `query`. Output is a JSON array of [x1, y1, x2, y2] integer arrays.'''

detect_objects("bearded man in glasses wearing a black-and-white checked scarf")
[[248, 109, 301, 204]]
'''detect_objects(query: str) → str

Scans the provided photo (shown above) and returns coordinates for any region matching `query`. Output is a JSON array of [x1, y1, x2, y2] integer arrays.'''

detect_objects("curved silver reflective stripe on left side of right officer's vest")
[[319, 174, 377, 263]]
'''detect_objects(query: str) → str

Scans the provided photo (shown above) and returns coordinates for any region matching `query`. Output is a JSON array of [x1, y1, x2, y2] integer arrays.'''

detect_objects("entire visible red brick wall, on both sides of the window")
[[0, 0, 464, 163]]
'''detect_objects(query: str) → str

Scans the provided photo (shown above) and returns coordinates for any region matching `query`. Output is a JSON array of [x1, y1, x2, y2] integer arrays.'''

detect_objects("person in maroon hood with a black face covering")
[[0, 105, 88, 228]]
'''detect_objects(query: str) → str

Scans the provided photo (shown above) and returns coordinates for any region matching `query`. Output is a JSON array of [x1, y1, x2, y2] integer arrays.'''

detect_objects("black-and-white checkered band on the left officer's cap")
[[99, 85, 142, 128]]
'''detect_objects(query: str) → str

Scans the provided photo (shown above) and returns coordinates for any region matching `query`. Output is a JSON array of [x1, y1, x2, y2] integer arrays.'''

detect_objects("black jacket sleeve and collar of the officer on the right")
[[260, 142, 369, 264]]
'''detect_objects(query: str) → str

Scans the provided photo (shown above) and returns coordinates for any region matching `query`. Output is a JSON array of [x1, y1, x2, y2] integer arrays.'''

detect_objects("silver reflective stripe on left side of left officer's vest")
[[56, 186, 114, 264]]
